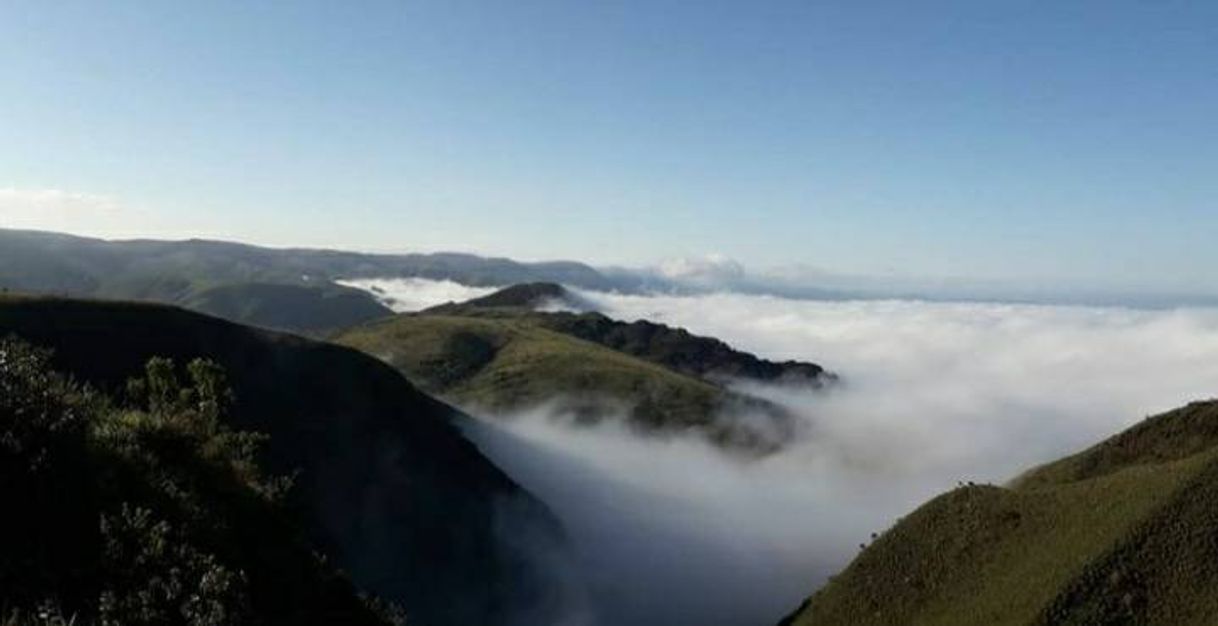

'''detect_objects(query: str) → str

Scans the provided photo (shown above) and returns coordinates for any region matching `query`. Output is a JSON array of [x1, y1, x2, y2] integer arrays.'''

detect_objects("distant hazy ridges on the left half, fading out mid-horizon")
[[0, 229, 613, 336]]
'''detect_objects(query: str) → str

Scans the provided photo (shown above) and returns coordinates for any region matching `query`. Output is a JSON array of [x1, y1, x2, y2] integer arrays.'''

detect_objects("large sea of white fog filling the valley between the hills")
[[353, 277, 1218, 626]]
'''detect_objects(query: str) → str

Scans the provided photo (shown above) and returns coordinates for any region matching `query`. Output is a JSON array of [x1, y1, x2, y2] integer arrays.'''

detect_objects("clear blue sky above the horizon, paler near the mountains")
[[0, 0, 1218, 292]]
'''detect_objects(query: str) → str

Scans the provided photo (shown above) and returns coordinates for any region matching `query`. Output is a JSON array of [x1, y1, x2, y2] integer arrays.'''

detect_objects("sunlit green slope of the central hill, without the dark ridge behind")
[[337, 314, 777, 446]]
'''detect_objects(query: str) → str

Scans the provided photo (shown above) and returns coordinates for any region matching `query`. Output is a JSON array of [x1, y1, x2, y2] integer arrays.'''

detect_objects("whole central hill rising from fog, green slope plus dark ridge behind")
[[335, 284, 827, 452]]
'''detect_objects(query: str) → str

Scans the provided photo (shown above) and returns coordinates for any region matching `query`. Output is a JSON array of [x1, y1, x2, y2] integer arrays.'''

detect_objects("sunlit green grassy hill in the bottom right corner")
[[784, 401, 1218, 626]]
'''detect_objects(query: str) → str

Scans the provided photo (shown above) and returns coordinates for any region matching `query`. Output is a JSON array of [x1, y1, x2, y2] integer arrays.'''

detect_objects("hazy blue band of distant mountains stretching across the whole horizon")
[[7, 229, 1218, 323]]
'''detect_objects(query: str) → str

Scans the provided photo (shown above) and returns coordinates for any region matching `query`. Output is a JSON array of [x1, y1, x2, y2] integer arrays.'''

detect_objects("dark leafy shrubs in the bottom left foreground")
[[0, 340, 394, 626]]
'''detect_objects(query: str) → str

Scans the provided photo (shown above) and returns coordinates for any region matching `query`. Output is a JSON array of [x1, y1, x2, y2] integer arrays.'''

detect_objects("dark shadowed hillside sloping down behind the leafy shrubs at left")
[[0, 296, 577, 625]]
